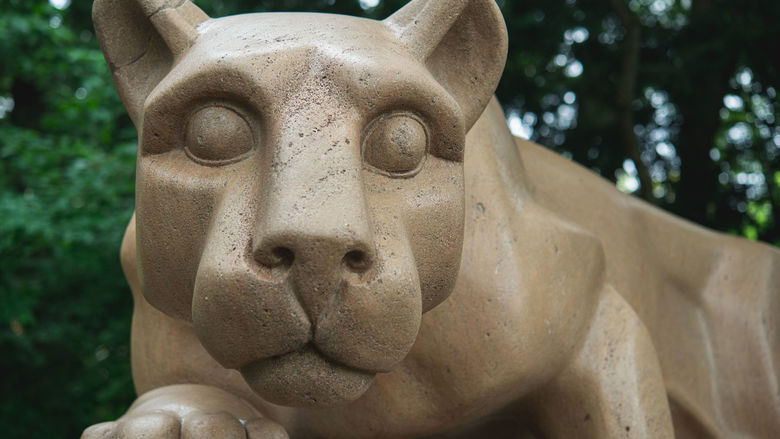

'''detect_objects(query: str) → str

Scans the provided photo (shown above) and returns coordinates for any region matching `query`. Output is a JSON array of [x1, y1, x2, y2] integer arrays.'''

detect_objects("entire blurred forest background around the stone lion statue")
[[0, 0, 780, 438]]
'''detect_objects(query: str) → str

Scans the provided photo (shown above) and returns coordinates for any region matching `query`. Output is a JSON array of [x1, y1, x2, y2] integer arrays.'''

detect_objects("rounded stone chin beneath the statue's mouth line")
[[240, 346, 376, 408]]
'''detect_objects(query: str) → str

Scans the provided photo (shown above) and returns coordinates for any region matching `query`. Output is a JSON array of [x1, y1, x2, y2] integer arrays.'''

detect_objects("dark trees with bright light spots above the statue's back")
[[497, 0, 780, 245]]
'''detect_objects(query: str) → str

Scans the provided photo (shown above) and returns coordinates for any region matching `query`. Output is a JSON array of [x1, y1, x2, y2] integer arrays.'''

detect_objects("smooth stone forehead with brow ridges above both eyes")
[[147, 13, 450, 124]]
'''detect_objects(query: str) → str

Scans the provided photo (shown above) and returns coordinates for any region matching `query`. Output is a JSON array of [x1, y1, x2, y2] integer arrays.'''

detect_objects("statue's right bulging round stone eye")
[[363, 114, 428, 177]]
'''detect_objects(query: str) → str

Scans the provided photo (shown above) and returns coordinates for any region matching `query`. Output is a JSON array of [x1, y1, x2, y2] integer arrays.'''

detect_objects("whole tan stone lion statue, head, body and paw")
[[83, 0, 780, 439]]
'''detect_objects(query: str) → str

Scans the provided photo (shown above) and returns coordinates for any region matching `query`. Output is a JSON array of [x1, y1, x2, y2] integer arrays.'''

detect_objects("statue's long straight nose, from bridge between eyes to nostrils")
[[251, 113, 375, 321]]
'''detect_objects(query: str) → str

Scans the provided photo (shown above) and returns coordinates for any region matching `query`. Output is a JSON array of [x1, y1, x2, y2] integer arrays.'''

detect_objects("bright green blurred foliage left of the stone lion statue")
[[0, 2, 135, 438]]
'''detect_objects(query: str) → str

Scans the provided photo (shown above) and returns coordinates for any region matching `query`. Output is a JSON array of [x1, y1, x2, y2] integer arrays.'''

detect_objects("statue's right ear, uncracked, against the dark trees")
[[385, 0, 507, 128]]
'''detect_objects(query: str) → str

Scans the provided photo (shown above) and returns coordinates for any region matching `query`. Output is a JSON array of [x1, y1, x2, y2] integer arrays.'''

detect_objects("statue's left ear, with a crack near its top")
[[92, 0, 208, 126]]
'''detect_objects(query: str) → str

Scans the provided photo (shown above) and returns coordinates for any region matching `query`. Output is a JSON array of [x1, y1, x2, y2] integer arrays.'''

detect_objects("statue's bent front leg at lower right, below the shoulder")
[[531, 287, 674, 439]]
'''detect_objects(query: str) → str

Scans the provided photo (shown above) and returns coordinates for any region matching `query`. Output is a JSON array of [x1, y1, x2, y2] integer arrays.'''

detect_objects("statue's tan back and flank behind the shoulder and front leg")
[[518, 137, 780, 437]]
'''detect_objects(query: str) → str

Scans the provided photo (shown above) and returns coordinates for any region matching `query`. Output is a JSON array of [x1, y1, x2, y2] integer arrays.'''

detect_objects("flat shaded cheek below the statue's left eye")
[[136, 151, 224, 321]]
